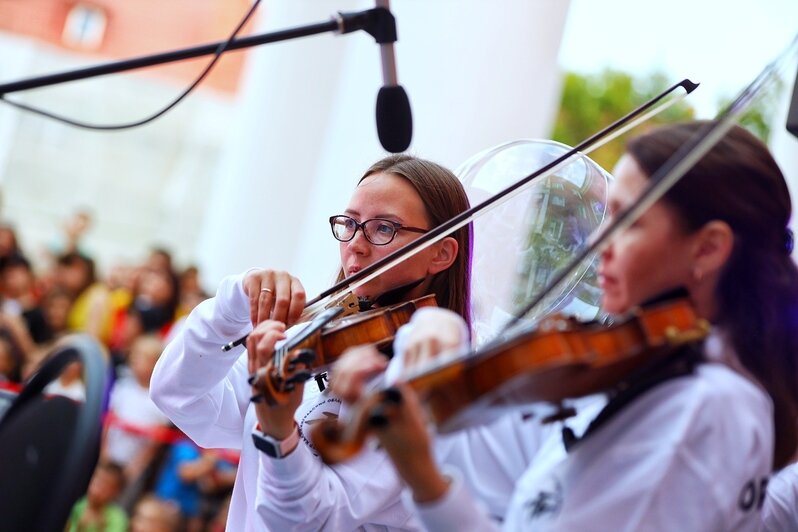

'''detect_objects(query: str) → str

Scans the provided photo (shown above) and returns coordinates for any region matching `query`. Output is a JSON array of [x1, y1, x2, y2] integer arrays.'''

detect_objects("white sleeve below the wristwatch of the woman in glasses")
[[255, 436, 415, 531]]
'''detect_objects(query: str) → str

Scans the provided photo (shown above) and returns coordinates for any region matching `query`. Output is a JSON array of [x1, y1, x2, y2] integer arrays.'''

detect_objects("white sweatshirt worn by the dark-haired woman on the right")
[[417, 344, 773, 532]]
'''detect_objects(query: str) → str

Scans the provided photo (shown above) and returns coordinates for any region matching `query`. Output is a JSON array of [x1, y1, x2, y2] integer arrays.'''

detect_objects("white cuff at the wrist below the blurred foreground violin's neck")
[[412, 468, 499, 532]]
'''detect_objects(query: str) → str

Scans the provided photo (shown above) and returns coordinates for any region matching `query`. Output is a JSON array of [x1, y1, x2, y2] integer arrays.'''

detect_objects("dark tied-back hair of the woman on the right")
[[627, 122, 798, 468]]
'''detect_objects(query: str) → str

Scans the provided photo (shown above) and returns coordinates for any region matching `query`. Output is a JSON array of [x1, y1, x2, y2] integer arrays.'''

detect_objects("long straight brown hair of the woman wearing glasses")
[[338, 154, 472, 326]]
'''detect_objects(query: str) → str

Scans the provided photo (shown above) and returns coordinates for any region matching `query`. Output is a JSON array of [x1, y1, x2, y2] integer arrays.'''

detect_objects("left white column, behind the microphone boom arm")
[[197, 1, 352, 286]]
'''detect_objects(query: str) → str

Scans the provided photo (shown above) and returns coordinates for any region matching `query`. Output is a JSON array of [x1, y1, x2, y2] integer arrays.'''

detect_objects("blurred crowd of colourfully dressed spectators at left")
[[0, 212, 238, 532]]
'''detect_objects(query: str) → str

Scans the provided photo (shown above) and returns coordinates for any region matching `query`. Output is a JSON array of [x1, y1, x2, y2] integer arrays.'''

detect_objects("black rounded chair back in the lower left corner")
[[0, 334, 112, 532]]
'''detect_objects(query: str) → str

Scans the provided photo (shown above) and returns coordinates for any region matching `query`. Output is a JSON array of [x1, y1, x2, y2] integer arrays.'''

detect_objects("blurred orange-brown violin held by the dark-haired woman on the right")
[[311, 298, 709, 464]]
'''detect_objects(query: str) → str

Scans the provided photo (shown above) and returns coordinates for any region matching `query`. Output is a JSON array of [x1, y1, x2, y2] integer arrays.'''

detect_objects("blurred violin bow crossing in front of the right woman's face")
[[497, 35, 798, 338]]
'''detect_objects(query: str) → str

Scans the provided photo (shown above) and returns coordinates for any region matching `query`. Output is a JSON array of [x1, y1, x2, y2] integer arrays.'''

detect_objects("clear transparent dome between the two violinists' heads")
[[456, 140, 612, 345]]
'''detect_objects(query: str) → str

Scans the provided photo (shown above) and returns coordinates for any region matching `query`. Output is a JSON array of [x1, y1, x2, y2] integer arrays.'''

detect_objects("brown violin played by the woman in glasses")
[[249, 294, 437, 404]]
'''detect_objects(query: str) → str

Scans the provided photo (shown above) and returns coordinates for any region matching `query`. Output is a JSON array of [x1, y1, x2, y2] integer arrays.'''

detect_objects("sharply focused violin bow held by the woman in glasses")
[[222, 79, 698, 351]]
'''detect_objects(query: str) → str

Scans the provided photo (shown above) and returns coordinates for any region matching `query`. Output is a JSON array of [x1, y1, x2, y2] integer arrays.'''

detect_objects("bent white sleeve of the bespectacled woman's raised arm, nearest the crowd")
[[150, 274, 252, 449]]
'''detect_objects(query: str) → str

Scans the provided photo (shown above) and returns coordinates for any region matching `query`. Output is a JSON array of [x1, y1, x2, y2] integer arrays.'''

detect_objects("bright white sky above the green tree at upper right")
[[560, 0, 798, 118]]
